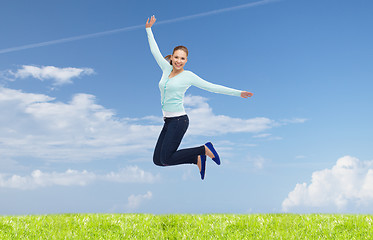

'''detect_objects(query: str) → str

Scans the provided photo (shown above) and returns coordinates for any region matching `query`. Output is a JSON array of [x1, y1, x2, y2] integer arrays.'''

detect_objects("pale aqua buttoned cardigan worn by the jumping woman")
[[146, 28, 241, 113]]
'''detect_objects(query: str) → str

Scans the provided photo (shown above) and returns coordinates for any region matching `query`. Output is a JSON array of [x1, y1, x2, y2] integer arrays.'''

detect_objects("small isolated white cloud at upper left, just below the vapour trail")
[[10, 65, 94, 86]]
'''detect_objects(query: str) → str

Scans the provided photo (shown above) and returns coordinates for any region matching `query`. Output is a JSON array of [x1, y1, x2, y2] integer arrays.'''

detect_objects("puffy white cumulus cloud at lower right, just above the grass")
[[282, 156, 373, 212]]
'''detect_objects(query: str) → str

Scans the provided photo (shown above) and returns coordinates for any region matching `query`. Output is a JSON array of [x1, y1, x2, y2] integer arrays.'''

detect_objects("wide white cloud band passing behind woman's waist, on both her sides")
[[0, 87, 294, 162]]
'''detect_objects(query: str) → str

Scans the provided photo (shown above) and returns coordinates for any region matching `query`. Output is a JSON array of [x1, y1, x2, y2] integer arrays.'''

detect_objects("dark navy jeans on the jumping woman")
[[153, 115, 205, 166]]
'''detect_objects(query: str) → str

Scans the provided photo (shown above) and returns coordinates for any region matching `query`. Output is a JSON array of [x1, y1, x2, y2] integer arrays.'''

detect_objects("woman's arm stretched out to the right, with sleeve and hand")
[[190, 72, 253, 98]]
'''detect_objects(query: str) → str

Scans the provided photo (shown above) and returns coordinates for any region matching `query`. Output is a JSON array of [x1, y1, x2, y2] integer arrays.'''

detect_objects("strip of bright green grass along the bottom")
[[0, 214, 373, 239]]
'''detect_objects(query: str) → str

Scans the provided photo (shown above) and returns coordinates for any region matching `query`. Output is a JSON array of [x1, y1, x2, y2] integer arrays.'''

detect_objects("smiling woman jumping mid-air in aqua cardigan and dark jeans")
[[145, 15, 253, 180]]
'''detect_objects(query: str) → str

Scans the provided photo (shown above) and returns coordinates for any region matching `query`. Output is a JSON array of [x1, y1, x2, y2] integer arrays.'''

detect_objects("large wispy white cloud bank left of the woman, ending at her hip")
[[0, 87, 161, 161]]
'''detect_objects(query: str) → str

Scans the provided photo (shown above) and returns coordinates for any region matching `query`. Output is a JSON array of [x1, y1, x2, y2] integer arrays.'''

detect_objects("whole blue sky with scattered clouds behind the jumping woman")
[[0, 0, 373, 215]]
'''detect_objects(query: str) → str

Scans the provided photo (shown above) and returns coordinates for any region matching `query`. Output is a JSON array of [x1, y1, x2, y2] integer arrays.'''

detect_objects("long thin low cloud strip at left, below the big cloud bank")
[[0, 166, 159, 190]]
